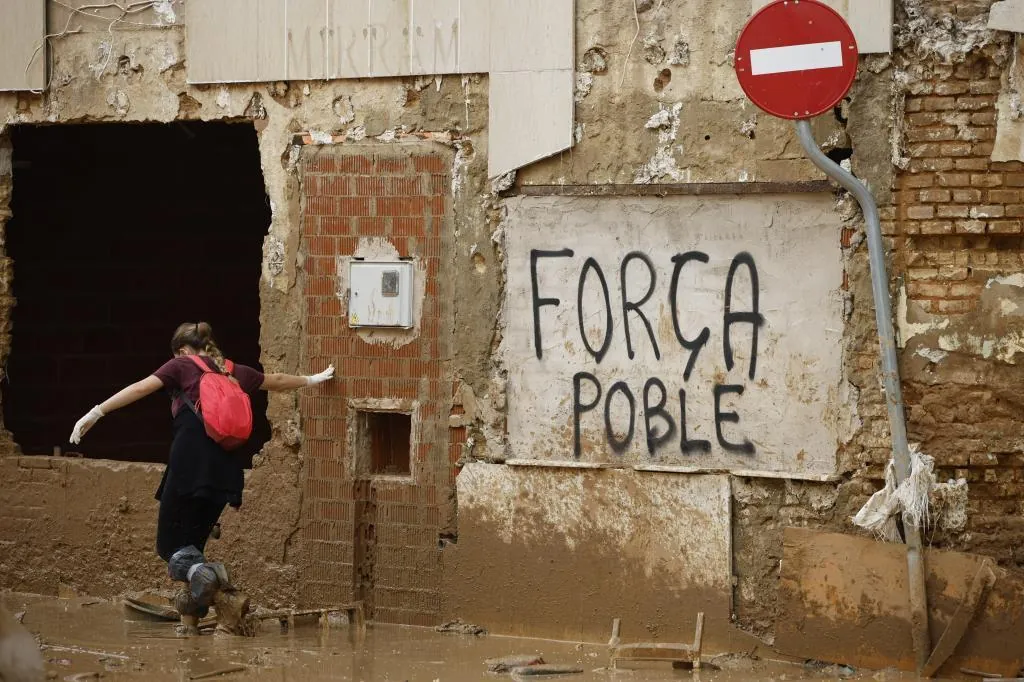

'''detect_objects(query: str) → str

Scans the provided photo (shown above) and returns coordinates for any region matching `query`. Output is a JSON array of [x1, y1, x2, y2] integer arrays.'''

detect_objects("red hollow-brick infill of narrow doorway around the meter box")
[[301, 144, 454, 625]]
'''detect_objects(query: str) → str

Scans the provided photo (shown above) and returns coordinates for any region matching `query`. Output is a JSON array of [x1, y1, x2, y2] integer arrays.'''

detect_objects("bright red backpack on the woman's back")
[[182, 355, 253, 450]]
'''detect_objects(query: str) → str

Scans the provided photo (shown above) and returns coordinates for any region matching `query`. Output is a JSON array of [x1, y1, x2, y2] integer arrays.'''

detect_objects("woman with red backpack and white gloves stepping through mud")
[[71, 322, 334, 620]]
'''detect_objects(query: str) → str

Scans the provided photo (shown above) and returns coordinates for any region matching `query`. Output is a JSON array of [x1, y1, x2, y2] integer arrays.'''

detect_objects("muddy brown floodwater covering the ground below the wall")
[[0, 594, 929, 682]]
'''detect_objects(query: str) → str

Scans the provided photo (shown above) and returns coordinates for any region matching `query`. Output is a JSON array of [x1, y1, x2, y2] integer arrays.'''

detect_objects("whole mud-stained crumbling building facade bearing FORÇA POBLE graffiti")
[[0, 0, 1024, 649]]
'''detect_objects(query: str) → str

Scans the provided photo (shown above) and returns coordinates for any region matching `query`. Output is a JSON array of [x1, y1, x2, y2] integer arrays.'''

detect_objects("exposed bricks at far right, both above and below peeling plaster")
[[876, 53, 1024, 564]]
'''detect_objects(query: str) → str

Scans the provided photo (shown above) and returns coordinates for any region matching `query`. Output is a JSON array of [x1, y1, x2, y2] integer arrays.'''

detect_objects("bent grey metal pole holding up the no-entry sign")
[[796, 120, 932, 673]]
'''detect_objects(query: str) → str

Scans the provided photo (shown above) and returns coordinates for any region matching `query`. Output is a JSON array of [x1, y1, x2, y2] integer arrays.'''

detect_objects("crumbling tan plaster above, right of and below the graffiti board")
[[481, 0, 896, 635]]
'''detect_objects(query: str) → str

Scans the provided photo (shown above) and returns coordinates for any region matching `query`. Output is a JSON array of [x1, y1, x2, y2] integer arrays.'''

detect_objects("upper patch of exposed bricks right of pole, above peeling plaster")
[[883, 54, 1024, 314]]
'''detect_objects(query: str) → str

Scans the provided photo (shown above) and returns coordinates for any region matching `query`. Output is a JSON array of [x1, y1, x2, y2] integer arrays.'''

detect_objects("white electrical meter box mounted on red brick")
[[348, 260, 415, 329]]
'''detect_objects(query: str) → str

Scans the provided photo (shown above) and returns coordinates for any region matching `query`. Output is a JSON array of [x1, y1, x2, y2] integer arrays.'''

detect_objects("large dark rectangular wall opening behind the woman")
[[3, 123, 270, 463]]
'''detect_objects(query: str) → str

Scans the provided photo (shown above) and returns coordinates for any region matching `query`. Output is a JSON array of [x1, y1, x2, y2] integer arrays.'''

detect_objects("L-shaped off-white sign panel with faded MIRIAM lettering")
[[183, 0, 575, 177]]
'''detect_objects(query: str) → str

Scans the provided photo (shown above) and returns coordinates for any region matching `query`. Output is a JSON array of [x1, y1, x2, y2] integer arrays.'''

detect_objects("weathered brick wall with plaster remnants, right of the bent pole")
[[877, 0, 1024, 565]]
